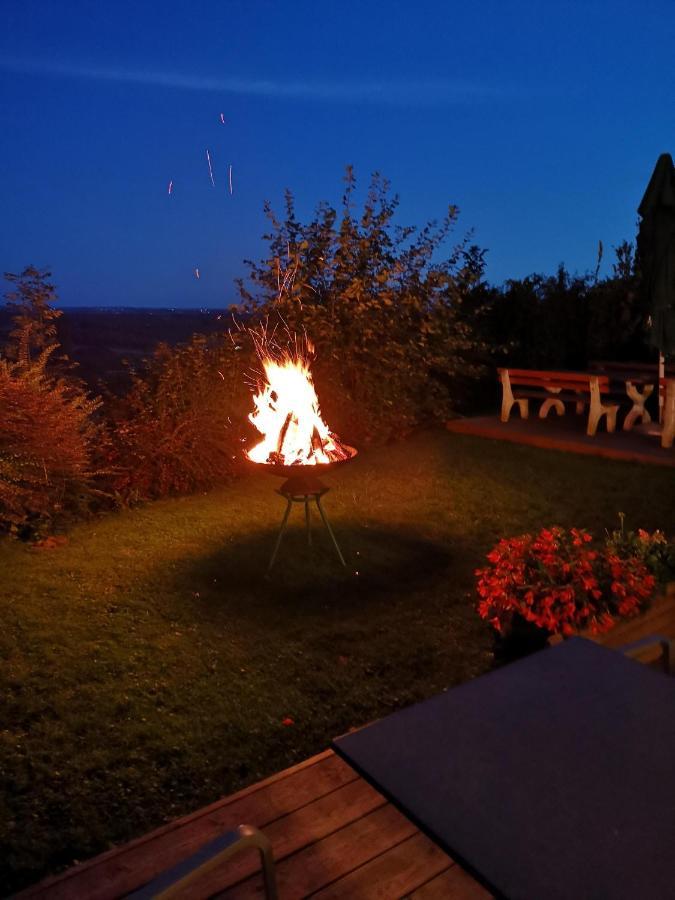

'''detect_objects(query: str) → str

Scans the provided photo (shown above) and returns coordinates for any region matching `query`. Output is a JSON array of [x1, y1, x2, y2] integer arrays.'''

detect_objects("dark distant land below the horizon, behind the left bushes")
[[0, 305, 239, 390]]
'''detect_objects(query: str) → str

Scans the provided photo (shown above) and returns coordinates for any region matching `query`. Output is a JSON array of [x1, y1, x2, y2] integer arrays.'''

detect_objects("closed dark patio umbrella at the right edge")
[[637, 153, 675, 420]]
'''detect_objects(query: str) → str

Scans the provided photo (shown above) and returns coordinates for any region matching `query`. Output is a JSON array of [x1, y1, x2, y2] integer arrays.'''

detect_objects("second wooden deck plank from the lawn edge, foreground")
[[154, 778, 386, 900]]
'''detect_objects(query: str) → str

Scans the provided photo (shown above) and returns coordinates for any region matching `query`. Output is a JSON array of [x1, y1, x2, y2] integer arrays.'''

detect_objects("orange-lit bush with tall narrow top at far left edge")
[[0, 266, 100, 533]]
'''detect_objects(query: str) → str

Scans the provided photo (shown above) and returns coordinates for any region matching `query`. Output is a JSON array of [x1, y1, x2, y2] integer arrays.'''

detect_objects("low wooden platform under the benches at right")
[[446, 413, 675, 466]]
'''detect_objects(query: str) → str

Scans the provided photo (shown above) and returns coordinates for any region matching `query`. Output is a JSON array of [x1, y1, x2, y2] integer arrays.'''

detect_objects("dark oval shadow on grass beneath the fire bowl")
[[166, 523, 466, 616]]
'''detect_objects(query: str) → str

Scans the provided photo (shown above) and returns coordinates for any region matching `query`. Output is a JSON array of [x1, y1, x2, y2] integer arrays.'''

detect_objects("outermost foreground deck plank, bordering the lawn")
[[18, 751, 358, 900]]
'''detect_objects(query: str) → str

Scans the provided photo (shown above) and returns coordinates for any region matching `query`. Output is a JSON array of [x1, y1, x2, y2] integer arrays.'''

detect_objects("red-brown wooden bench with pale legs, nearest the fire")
[[497, 368, 619, 436]]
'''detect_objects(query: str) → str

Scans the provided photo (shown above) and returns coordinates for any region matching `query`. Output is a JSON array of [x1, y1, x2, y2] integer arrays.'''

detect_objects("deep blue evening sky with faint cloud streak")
[[0, 0, 675, 306]]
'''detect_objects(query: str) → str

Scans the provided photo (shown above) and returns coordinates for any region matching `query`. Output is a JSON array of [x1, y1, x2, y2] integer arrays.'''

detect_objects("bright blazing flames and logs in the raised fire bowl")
[[246, 345, 355, 466]]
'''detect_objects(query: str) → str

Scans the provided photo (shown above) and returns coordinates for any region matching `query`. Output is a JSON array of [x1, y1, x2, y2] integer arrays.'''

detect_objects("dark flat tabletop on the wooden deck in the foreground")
[[333, 638, 675, 900]]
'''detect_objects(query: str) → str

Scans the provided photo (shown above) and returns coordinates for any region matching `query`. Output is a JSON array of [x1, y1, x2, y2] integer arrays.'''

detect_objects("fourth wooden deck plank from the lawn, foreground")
[[312, 832, 453, 900]]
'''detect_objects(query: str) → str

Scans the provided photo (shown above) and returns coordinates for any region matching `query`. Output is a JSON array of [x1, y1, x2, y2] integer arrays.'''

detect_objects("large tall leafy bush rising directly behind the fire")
[[239, 168, 492, 442]]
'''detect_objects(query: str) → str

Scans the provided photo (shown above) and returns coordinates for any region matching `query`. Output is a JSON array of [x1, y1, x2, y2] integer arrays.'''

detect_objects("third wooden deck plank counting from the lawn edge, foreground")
[[218, 803, 417, 900]]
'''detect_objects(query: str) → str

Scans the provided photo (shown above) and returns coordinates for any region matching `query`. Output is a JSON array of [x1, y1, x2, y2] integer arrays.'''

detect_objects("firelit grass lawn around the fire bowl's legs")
[[0, 431, 675, 890]]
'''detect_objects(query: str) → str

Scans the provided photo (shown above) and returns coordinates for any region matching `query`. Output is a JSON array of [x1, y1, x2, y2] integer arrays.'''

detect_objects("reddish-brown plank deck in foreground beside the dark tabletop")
[[19, 750, 491, 900]]
